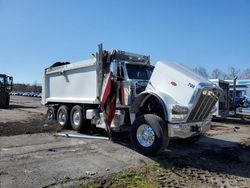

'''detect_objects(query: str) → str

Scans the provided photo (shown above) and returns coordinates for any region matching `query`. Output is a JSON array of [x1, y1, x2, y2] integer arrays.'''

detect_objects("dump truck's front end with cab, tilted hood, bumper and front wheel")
[[100, 50, 222, 154]]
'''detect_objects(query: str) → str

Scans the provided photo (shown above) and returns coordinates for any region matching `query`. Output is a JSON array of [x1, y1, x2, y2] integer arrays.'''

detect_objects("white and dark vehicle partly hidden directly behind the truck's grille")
[[209, 79, 230, 118]]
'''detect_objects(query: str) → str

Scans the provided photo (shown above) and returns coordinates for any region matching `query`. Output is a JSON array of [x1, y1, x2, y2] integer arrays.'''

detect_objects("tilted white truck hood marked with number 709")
[[146, 61, 214, 106]]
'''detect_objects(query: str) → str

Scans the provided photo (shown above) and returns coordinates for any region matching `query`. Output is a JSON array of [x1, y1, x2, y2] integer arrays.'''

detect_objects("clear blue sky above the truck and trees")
[[0, 0, 250, 84]]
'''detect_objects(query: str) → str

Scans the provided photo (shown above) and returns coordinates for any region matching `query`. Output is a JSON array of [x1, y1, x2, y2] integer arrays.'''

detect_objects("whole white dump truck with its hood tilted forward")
[[42, 45, 221, 155]]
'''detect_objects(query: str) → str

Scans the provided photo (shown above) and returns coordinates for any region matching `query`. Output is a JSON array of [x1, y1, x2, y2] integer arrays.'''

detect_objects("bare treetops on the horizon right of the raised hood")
[[193, 67, 250, 80]]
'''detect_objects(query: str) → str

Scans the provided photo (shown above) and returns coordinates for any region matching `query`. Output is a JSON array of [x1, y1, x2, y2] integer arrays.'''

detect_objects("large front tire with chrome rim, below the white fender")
[[130, 114, 169, 155]]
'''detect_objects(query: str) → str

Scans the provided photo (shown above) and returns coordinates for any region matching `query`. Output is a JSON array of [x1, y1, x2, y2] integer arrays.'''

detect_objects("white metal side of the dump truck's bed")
[[42, 59, 98, 104]]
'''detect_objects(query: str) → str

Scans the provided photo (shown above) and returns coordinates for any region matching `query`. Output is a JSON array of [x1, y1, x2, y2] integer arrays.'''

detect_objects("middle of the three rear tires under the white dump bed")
[[57, 105, 69, 129]]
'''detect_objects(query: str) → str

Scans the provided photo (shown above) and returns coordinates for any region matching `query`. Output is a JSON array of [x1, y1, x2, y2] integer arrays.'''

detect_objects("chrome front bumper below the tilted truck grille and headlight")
[[168, 120, 211, 138]]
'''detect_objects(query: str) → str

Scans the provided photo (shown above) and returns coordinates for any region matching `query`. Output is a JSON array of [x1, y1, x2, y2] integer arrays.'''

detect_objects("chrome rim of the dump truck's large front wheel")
[[136, 124, 155, 147]]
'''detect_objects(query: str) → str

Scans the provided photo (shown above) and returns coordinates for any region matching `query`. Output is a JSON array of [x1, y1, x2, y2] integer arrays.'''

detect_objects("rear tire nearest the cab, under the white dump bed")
[[70, 105, 84, 131]]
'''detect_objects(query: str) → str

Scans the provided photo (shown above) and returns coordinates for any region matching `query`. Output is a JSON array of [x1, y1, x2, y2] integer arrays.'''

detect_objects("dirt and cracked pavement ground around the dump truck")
[[0, 96, 250, 187]]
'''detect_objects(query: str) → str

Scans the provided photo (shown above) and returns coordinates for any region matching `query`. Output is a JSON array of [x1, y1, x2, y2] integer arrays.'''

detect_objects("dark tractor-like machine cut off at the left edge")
[[0, 74, 13, 107]]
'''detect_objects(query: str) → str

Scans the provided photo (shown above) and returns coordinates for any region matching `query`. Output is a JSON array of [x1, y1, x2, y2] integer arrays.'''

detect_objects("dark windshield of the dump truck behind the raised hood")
[[126, 64, 154, 80]]
